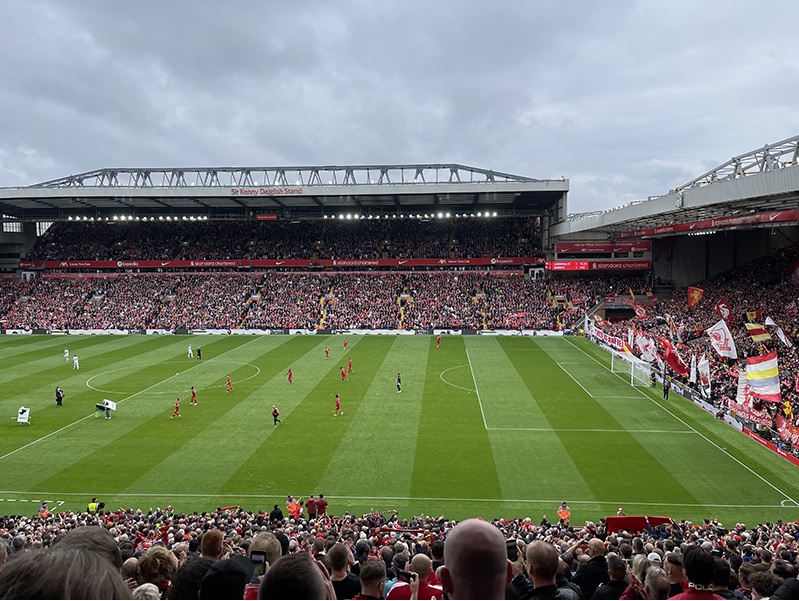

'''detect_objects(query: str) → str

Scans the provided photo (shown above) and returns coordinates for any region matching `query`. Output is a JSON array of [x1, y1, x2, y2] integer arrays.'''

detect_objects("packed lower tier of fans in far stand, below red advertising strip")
[[0, 271, 642, 330]]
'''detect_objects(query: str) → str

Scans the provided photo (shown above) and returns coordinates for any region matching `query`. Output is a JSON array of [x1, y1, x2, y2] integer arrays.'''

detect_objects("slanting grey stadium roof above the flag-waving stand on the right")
[[552, 136, 799, 236]]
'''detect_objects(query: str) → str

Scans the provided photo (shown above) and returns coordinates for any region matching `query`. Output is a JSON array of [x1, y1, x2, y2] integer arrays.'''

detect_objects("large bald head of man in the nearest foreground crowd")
[[439, 520, 512, 599]]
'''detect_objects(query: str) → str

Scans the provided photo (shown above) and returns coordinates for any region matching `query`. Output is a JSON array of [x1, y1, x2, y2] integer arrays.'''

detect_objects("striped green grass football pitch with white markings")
[[0, 335, 799, 525]]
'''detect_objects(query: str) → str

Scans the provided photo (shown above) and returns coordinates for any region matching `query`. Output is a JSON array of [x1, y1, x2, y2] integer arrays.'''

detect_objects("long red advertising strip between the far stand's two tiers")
[[18, 257, 544, 269]]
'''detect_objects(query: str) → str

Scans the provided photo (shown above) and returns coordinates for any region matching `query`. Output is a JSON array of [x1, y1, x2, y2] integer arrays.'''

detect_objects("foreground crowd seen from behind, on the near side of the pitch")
[[0, 505, 799, 600]]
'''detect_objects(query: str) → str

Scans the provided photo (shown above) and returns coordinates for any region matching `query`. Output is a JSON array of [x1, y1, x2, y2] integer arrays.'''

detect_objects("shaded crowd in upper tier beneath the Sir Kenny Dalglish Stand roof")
[[25, 217, 542, 261]]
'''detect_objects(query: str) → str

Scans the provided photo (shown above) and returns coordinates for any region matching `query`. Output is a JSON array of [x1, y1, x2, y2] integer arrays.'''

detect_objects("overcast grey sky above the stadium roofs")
[[0, 0, 799, 212]]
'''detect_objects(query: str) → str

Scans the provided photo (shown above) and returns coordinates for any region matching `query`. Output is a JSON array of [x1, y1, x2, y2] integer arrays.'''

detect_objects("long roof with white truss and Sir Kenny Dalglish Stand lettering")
[[0, 164, 569, 221]]
